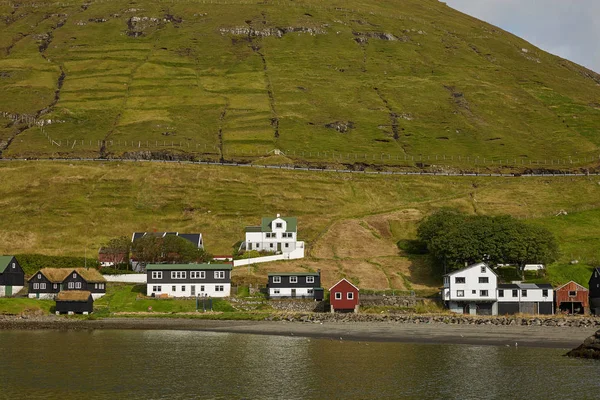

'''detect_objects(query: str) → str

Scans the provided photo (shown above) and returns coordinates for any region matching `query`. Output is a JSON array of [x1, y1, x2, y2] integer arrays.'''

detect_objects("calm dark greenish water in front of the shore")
[[0, 330, 600, 400]]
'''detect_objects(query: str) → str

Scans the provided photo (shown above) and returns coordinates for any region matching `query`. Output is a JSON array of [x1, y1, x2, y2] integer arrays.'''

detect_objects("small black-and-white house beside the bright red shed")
[[267, 271, 323, 301]]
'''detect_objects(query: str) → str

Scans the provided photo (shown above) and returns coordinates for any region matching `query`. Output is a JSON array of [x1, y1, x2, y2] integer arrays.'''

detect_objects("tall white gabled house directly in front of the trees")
[[442, 263, 498, 315]]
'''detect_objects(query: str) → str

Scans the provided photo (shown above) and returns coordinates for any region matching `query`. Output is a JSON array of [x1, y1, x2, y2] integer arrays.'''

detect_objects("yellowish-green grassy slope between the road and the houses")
[[0, 161, 600, 290]]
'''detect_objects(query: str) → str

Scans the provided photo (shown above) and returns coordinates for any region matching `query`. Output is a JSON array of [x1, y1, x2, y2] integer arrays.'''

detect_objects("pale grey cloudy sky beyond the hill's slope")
[[443, 0, 600, 73]]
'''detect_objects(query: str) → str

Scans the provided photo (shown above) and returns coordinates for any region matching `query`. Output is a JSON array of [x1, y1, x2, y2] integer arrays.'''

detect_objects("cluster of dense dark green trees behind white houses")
[[417, 210, 558, 271]]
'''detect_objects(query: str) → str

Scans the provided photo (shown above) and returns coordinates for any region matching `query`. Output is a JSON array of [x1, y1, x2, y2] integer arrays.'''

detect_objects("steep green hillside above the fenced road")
[[0, 0, 600, 167]]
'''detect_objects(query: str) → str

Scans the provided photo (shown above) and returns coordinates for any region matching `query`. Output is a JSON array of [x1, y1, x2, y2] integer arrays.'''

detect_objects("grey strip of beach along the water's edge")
[[0, 317, 597, 349]]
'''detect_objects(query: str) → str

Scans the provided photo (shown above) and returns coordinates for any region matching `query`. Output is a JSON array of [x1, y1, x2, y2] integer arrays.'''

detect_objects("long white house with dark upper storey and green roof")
[[146, 263, 233, 297]]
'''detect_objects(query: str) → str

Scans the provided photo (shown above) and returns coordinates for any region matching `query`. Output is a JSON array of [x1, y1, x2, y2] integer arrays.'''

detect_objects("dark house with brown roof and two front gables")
[[28, 268, 106, 299]]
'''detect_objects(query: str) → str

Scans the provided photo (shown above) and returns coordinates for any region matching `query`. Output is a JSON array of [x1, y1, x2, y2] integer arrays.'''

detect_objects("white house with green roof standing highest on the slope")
[[241, 214, 304, 259]]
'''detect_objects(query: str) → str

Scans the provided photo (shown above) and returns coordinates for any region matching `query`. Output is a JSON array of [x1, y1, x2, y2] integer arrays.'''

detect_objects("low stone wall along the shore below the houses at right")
[[267, 313, 600, 328]]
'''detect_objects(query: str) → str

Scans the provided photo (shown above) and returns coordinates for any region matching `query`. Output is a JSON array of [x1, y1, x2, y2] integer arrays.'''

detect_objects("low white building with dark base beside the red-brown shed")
[[497, 283, 554, 315]]
